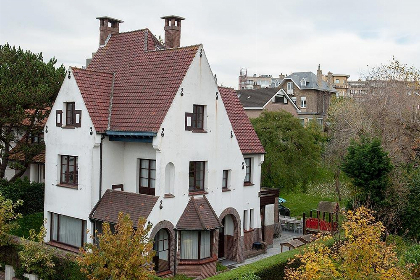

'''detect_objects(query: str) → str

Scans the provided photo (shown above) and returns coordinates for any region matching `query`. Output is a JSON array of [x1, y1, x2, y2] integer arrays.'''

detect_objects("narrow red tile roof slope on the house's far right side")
[[219, 87, 265, 154]]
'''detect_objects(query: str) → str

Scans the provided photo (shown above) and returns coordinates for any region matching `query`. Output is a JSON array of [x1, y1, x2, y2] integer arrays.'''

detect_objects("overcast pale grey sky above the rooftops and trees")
[[0, 0, 420, 88]]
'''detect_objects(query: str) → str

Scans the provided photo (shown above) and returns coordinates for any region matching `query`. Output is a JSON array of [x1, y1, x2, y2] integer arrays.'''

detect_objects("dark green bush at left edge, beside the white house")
[[0, 177, 45, 215]]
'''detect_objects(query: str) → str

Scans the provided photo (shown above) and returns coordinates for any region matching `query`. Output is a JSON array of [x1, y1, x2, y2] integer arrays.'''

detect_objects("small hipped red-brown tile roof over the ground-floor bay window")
[[176, 197, 222, 230]]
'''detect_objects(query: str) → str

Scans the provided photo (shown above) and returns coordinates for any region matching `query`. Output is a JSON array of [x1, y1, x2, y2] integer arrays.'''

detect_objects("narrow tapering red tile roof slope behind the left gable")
[[71, 67, 113, 132]]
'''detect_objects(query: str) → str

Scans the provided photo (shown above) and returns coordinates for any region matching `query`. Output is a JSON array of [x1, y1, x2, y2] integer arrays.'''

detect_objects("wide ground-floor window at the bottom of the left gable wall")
[[50, 213, 86, 247]]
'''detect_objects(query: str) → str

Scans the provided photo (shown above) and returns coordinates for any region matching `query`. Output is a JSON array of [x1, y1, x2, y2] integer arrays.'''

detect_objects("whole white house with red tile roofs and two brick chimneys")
[[44, 16, 275, 278]]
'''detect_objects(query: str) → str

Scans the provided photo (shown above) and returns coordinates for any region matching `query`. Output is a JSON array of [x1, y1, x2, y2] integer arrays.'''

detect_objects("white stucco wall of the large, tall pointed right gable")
[[149, 46, 262, 236]]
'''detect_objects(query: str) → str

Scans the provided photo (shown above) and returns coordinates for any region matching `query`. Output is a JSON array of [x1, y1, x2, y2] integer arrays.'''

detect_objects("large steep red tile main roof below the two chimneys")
[[83, 29, 199, 132]]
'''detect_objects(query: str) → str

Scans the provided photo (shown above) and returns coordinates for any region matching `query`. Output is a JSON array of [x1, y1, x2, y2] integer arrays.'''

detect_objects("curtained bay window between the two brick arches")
[[181, 231, 212, 260]]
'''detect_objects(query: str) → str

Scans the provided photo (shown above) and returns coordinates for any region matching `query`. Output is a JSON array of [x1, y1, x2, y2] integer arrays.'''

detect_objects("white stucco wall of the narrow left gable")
[[44, 71, 100, 241]]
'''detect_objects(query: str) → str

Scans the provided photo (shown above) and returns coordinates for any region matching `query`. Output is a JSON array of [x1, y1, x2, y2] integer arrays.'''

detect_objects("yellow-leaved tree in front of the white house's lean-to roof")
[[77, 213, 155, 280]]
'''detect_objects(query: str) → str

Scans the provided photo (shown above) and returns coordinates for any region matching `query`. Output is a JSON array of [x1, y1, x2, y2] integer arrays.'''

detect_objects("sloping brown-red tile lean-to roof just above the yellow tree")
[[89, 189, 159, 225]]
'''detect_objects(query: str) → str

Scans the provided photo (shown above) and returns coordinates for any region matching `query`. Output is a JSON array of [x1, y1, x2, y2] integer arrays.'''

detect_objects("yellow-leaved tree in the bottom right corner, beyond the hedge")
[[286, 207, 409, 280]]
